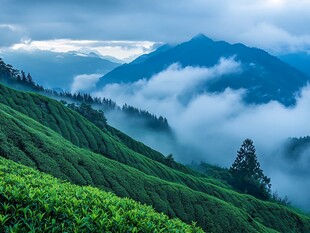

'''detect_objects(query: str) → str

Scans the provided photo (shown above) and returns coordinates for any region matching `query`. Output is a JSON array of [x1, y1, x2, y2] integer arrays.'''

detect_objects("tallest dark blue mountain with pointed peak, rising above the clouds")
[[97, 34, 309, 105]]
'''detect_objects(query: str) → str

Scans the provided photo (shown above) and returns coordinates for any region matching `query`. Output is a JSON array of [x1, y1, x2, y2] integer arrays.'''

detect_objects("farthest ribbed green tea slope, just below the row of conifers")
[[0, 84, 194, 177]]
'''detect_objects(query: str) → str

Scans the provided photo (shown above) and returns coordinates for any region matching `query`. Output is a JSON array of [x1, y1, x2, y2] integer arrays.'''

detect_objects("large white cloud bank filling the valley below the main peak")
[[95, 58, 310, 209]]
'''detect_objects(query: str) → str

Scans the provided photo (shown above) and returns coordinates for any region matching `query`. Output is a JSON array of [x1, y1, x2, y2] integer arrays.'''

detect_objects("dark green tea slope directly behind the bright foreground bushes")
[[0, 104, 266, 231]]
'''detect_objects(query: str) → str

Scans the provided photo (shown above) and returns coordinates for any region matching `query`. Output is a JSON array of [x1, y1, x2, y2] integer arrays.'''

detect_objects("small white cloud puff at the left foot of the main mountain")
[[71, 74, 102, 93]]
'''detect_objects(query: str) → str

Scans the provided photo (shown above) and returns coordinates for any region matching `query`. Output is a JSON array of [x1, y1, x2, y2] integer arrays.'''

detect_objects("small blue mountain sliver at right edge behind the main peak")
[[279, 52, 310, 76]]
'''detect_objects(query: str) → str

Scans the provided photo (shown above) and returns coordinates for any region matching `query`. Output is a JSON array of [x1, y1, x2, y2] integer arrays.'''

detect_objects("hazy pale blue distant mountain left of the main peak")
[[0, 50, 120, 91]]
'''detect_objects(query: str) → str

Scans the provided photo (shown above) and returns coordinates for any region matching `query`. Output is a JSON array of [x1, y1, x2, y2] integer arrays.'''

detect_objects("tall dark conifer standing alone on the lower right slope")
[[229, 139, 271, 199]]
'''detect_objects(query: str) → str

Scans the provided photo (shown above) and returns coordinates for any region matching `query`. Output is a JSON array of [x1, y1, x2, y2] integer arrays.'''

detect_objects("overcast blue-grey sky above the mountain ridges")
[[0, 0, 310, 59]]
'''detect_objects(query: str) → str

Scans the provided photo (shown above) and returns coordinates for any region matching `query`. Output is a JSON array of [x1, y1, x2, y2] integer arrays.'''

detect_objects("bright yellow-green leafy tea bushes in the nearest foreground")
[[0, 157, 202, 232]]
